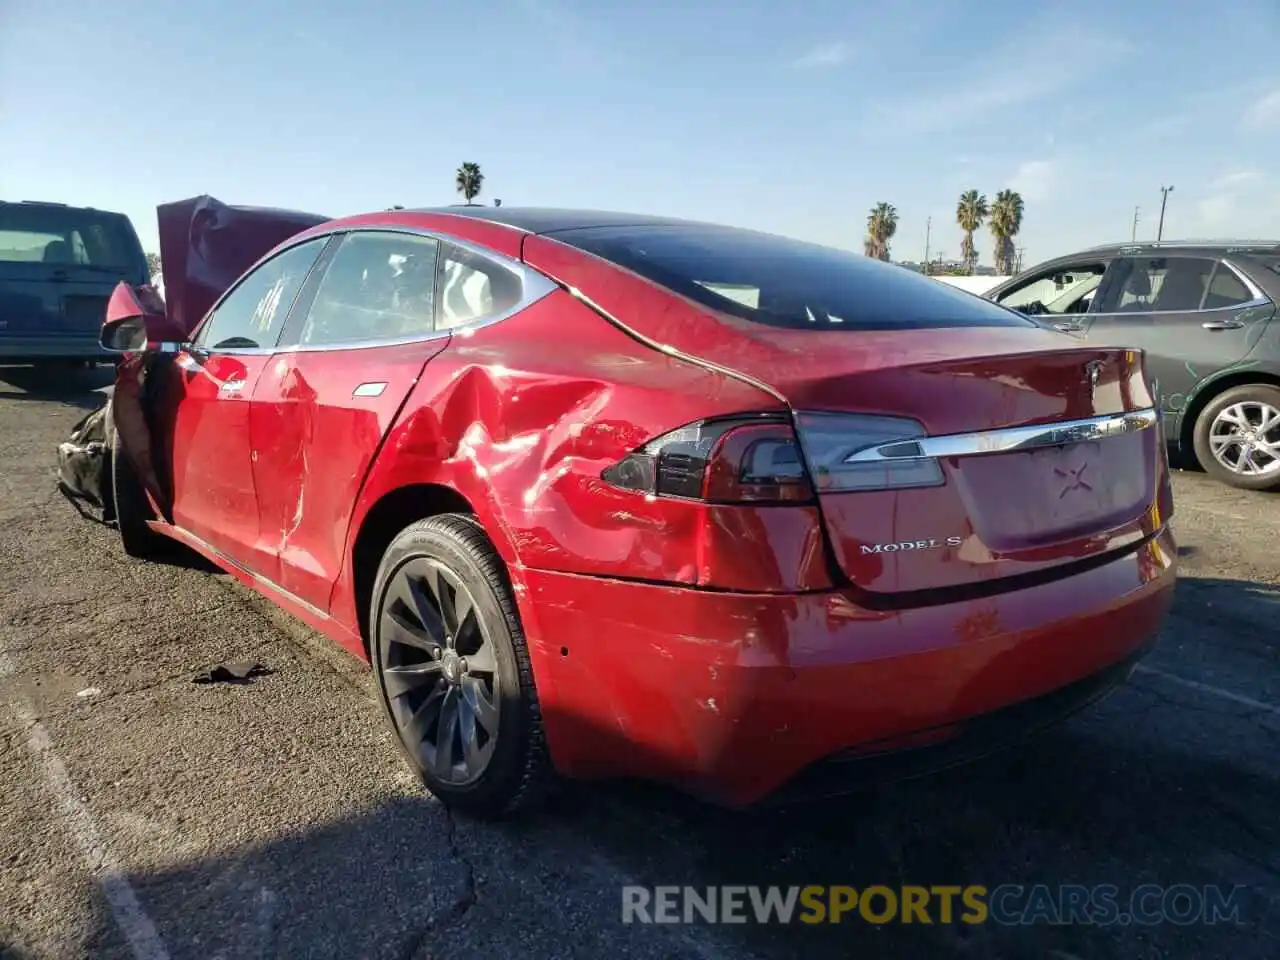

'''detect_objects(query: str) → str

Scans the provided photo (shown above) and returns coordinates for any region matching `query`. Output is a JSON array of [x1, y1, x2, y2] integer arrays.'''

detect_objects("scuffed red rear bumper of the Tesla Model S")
[[520, 529, 1176, 805]]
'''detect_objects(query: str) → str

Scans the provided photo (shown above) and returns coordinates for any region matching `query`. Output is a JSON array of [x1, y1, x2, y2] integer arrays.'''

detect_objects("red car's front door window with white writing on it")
[[196, 237, 328, 349]]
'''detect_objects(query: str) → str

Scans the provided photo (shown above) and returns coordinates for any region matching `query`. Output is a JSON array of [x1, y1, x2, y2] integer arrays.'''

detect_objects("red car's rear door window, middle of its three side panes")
[[298, 230, 439, 347]]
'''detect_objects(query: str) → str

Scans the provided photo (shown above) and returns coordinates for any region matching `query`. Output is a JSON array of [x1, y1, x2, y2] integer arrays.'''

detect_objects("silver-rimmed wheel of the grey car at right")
[[1194, 384, 1280, 490]]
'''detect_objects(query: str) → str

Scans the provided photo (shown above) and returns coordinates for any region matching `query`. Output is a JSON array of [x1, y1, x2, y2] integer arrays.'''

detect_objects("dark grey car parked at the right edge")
[[984, 241, 1280, 490]]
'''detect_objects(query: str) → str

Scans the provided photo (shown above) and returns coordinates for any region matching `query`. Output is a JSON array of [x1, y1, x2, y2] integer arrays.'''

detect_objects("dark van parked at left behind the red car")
[[0, 201, 147, 364]]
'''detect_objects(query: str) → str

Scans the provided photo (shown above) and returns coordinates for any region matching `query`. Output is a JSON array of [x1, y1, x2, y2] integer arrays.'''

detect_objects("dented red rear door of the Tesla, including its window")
[[250, 230, 449, 611]]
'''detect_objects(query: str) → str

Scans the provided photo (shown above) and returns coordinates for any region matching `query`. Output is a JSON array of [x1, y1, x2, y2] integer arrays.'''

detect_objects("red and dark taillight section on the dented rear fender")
[[602, 417, 813, 504]]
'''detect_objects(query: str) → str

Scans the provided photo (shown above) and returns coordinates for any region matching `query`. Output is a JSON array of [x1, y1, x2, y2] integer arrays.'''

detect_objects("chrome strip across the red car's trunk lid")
[[845, 407, 1158, 463]]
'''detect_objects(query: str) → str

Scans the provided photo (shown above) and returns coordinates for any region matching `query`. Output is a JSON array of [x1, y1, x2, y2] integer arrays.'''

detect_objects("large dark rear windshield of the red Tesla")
[[552, 224, 1034, 330]]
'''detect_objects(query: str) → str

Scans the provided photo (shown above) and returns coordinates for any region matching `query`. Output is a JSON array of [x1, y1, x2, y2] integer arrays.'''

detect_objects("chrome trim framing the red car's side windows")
[[196, 225, 558, 356]]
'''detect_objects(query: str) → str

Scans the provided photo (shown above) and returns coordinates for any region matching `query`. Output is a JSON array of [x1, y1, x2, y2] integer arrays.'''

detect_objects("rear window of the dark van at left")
[[0, 204, 142, 270]]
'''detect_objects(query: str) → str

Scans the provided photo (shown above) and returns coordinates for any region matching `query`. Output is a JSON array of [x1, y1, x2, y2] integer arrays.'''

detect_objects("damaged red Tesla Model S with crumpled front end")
[[102, 197, 1176, 815]]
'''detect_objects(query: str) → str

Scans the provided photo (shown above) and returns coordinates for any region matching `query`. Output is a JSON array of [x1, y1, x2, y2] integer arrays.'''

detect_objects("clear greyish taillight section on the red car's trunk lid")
[[796, 413, 943, 493]]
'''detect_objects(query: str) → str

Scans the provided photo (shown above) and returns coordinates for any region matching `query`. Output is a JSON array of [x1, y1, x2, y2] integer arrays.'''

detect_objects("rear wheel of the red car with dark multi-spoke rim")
[[369, 513, 553, 819]]
